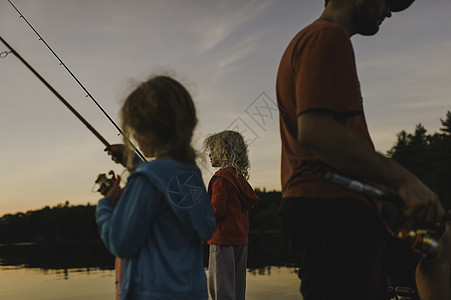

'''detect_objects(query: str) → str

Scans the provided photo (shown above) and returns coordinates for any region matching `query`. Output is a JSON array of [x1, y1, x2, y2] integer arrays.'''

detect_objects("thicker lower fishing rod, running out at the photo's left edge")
[[0, 36, 145, 166]]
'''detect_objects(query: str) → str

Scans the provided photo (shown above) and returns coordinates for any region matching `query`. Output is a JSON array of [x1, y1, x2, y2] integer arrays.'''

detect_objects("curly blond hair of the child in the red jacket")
[[204, 130, 250, 180]]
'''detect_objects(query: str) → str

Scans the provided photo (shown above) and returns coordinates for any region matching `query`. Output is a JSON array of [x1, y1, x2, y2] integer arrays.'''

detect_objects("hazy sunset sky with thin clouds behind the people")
[[0, 0, 451, 216]]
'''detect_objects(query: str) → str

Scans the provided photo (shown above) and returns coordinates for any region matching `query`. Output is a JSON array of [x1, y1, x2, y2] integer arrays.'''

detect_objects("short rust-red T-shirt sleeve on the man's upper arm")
[[293, 26, 363, 115]]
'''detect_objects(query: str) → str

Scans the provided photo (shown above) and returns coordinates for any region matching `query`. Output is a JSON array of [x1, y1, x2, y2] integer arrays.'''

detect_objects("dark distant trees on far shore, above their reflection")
[[0, 189, 282, 244]]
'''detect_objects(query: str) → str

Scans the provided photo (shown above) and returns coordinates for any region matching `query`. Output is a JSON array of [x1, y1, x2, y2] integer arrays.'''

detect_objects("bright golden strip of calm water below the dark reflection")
[[0, 266, 302, 300]]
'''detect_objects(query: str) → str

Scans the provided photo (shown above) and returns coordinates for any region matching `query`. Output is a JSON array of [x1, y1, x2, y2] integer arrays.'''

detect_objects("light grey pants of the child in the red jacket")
[[208, 245, 247, 300]]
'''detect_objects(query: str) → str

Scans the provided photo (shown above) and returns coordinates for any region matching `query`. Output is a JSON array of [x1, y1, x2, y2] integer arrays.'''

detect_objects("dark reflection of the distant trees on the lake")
[[0, 231, 291, 270]]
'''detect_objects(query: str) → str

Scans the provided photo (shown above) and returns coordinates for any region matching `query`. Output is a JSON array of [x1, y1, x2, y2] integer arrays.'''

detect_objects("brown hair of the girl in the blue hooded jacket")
[[120, 75, 197, 161]]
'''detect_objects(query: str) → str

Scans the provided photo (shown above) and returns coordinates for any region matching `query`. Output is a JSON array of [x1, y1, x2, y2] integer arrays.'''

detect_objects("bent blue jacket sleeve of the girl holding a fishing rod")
[[96, 174, 162, 258]]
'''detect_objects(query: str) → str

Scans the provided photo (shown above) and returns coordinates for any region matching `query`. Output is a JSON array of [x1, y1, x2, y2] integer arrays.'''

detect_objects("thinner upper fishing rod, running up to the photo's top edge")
[[8, 0, 146, 161]]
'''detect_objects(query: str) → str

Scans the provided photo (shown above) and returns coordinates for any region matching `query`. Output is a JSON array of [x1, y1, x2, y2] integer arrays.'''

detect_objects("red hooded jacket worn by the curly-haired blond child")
[[207, 168, 258, 245]]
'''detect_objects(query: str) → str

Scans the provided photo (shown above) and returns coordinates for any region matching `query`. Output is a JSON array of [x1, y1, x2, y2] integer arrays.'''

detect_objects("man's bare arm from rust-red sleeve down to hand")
[[298, 112, 444, 223]]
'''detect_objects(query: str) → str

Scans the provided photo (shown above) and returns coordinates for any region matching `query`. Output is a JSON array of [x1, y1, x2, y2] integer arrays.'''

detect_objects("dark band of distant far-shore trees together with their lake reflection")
[[0, 190, 290, 269]]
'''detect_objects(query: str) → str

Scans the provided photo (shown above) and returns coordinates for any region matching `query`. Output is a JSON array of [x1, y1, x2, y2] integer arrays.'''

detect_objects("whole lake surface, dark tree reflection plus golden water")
[[0, 241, 302, 300]]
